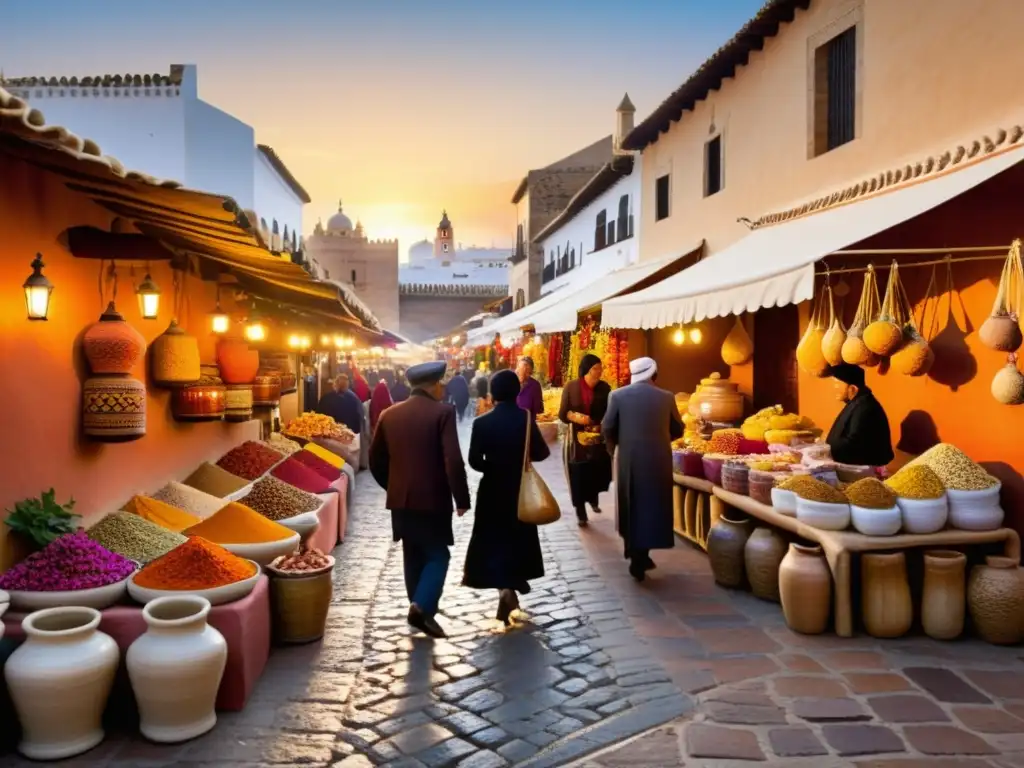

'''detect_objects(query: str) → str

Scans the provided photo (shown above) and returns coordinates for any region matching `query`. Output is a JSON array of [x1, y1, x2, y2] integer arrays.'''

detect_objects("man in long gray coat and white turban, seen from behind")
[[601, 357, 683, 582]]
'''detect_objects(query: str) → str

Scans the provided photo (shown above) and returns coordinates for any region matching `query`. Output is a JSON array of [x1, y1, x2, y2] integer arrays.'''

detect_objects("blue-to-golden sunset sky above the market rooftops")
[[0, 0, 762, 258]]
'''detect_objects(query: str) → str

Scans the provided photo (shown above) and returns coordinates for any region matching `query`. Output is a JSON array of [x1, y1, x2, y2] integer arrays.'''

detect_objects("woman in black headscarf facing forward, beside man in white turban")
[[558, 354, 611, 527]]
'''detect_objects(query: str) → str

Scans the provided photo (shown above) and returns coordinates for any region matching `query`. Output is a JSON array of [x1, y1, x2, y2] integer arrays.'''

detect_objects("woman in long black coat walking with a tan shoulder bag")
[[462, 371, 551, 626]]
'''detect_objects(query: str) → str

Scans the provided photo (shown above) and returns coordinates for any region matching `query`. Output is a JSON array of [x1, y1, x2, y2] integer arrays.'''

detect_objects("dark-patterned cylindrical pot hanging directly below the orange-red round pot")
[[82, 376, 145, 442]]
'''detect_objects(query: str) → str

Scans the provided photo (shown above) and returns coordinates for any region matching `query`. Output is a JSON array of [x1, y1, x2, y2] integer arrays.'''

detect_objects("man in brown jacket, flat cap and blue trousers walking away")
[[370, 362, 470, 638]]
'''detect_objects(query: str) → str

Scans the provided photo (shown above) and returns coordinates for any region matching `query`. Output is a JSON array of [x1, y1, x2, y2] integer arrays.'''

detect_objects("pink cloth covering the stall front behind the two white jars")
[[3, 575, 270, 712]]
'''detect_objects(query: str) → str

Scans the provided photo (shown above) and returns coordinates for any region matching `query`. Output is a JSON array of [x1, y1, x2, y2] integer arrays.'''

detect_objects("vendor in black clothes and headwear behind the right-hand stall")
[[825, 362, 894, 467]]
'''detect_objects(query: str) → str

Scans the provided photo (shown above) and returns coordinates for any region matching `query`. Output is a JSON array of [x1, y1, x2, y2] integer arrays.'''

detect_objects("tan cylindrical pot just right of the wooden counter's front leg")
[[860, 552, 913, 638]]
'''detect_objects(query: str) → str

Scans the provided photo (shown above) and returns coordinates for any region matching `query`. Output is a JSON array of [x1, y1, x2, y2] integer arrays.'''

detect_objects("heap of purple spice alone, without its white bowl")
[[0, 530, 135, 592]]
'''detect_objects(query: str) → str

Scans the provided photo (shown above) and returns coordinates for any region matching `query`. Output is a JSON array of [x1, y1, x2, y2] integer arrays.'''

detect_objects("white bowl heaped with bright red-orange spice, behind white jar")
[[128, 537, 260, 605]]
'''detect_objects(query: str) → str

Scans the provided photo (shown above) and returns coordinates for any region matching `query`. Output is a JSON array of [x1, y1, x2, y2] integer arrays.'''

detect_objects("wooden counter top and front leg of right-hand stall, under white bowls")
[[712, 489, 1021, 637]]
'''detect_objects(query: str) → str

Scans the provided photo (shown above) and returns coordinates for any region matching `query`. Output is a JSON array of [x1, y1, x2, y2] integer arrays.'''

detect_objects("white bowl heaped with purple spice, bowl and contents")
[[0, 530, 138, 610]]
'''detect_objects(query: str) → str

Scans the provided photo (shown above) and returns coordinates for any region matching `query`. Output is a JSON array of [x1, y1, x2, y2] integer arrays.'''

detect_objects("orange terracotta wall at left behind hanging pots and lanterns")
[[0, 156, 258, 568]]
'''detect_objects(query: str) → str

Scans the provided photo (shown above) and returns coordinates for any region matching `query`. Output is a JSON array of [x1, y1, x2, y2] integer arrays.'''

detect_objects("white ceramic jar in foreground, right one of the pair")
[[126, 595, 227, 743]]
